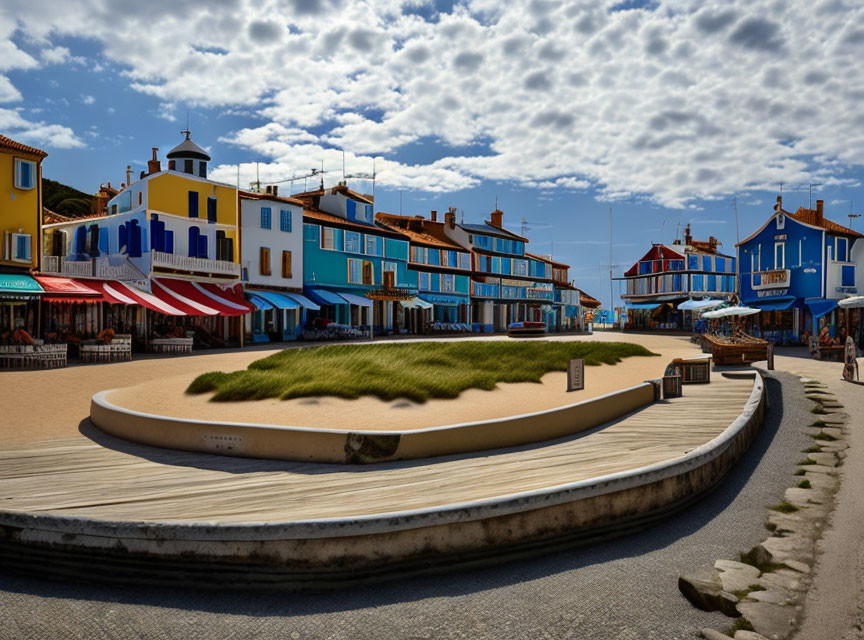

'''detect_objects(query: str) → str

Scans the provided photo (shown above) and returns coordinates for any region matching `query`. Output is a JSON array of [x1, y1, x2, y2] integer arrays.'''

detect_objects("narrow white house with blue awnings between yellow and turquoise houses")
[[240, 187, 319, 342]]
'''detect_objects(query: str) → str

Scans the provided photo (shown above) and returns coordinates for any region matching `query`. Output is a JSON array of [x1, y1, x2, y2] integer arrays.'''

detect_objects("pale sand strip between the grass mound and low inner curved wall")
[[108, 336, 695, 430]]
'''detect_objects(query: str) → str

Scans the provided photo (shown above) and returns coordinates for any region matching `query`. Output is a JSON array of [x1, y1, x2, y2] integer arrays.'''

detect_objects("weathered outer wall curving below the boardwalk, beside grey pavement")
[[0, 376, 765, 589]]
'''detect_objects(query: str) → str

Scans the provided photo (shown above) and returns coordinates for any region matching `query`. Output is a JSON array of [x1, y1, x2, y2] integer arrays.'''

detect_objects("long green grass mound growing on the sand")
[[186, 340, 657, 402]]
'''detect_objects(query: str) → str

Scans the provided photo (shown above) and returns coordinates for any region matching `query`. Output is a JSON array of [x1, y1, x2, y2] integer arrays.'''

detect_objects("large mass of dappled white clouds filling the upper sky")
[[0, 0, 864, 207]]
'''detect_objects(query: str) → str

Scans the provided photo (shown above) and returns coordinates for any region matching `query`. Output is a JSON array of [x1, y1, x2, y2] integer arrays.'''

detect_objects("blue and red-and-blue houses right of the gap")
[[619, 196, 864, 346]]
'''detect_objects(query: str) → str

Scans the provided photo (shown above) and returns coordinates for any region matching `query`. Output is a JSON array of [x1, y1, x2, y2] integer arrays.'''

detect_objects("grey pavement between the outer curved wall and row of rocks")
[[0, 374, 811, 640]]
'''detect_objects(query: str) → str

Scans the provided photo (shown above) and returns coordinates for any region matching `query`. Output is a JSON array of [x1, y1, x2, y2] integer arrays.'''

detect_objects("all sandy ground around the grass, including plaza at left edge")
[[0, 333, 698, 446]]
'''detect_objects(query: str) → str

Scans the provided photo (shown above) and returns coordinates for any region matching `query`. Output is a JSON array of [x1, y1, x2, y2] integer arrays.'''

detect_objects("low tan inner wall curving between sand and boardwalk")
[[90, 383, 654, 464]]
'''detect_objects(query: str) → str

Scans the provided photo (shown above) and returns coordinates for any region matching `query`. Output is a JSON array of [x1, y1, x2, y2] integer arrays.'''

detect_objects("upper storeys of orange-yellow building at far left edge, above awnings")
[[0, 135, 48, 272]]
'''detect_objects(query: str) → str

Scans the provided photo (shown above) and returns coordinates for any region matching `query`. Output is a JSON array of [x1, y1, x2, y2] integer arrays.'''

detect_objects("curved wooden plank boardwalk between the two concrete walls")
[[0, 372, 753, 522]]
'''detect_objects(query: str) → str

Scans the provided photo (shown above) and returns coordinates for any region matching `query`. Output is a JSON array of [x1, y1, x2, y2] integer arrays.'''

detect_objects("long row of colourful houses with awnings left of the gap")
[[0, 131, 599, 346]]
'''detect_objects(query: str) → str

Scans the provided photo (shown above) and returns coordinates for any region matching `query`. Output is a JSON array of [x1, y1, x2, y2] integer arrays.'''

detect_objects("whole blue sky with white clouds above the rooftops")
[[0, 0, 864, 300]]
